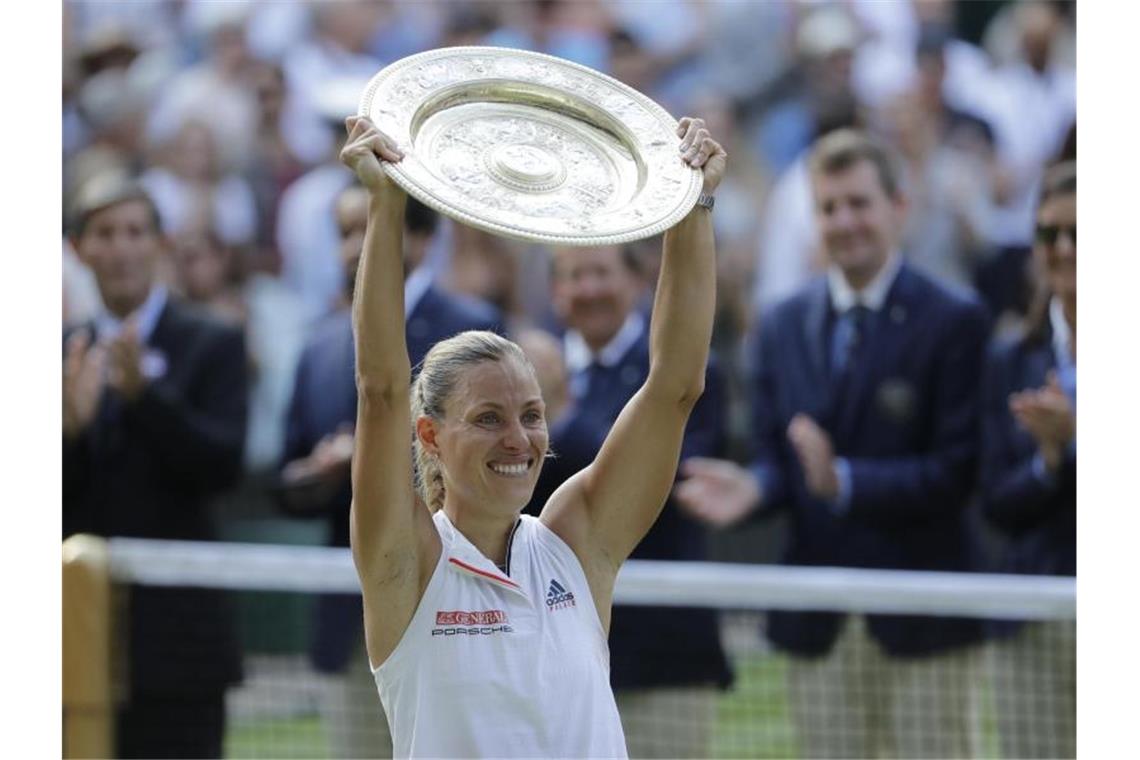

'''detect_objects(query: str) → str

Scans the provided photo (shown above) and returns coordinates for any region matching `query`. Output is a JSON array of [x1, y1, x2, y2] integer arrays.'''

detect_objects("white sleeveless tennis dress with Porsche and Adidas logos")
[[373, 510, 626, 758]]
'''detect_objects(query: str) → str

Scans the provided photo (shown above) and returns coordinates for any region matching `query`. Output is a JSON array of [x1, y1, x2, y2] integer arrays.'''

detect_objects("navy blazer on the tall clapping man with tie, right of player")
[[752, 264, 988, 655]]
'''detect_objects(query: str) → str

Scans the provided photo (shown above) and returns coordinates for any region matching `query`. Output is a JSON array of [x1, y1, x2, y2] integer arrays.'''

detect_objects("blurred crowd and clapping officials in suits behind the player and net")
[[62, 0, 1076, 757]]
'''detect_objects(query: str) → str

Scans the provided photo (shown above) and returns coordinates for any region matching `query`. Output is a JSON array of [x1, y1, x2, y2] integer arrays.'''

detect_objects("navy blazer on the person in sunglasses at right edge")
[[982, 330, 1076, 575]]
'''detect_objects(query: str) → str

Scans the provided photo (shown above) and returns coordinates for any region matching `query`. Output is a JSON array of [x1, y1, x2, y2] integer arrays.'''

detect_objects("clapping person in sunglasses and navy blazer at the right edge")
[[982, 163, 1076, 758]]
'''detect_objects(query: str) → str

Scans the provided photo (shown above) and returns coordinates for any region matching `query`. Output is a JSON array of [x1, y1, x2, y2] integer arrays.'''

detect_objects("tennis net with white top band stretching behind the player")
[[65, 539, 1076, 758]]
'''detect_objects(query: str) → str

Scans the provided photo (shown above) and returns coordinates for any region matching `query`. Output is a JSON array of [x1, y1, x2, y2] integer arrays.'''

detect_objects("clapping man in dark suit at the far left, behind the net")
[[63, 174, 247, 758]]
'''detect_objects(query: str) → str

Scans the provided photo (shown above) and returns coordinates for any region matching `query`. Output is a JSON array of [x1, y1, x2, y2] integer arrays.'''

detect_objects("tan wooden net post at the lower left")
[[63, 536, 114, 758]]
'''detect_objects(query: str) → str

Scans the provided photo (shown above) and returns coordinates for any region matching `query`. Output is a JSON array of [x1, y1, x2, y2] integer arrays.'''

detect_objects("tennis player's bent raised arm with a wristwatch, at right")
[[543, 117, 726, 598]]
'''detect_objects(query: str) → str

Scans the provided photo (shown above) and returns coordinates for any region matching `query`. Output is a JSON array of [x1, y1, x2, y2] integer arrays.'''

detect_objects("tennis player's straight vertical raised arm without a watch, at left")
[[341, 117, 439, 665]]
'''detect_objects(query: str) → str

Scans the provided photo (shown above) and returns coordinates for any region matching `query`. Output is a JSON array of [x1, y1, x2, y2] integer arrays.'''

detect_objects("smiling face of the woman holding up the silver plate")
[[435, 359, 549, 513]]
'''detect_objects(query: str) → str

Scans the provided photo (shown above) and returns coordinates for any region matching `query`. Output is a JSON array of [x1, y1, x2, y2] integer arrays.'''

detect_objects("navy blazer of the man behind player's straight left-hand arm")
[[285, 286, 503, 672]]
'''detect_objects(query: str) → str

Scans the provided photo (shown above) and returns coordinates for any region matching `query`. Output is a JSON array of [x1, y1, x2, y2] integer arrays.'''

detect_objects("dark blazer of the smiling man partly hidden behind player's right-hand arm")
[[527, 330, 732, 688]]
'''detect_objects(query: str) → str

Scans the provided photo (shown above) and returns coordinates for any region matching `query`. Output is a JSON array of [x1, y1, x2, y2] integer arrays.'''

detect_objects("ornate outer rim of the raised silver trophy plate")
[[357, 46, 703, 246]]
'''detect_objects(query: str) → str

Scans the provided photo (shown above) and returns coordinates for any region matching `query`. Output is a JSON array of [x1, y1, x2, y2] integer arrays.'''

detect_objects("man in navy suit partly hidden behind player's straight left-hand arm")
[[283, 185, 502, 758]]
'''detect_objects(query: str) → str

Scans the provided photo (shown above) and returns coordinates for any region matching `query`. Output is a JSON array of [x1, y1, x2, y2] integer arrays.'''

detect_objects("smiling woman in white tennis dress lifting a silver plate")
[[341, 111, 725, 757]]
